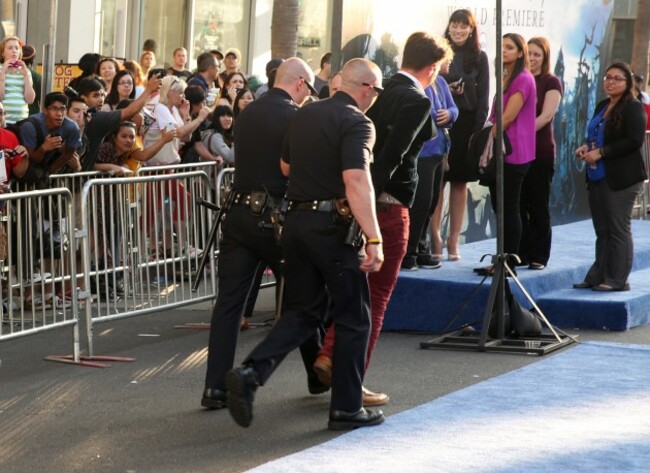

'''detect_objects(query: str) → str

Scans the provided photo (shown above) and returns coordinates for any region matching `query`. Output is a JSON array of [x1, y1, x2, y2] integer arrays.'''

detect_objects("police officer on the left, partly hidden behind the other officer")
[[201, 58, 328, 409]]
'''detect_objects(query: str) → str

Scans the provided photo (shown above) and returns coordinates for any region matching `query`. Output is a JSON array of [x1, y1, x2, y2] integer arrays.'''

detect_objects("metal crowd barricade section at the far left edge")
[[0, 185, 80, 362]]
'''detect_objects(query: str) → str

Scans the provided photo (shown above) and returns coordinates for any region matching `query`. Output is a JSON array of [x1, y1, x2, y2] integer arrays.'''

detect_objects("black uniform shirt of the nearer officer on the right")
[[284, 92, 375, 201]]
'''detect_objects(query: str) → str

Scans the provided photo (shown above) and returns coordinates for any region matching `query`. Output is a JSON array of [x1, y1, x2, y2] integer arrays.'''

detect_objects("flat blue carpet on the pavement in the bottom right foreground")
[[250, 342, 650, 473]]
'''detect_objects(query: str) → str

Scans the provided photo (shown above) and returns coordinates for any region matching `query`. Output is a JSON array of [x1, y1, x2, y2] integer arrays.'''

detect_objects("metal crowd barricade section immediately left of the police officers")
[[80, 171, 216, 359]]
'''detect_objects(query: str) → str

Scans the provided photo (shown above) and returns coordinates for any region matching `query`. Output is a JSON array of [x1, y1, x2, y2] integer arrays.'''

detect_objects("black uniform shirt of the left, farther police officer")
[[233, 88, 298, 197]]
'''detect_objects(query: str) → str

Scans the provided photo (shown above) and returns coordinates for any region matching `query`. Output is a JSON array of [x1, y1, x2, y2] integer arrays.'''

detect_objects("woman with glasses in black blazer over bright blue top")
[[573, 62, 647, 291]]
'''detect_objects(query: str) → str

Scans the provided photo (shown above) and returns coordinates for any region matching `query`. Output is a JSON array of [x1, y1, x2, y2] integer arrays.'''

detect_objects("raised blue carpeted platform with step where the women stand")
[[384, 220, 650, 332]]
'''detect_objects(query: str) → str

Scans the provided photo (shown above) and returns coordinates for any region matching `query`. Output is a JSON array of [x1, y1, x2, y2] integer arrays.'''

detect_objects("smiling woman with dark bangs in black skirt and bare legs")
[[431, 9, 490, 261]]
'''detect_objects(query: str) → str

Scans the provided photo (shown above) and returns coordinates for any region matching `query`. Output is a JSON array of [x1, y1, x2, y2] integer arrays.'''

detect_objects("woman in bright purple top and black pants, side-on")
[[477, 33, 536, 275]]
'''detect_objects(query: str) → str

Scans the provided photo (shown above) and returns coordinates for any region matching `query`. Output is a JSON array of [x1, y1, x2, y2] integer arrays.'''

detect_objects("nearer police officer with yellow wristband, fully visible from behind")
[[226, 59, 384, 430]]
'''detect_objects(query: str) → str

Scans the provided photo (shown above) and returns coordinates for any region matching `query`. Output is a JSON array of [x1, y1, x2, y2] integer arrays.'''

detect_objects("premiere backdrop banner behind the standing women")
[[342, 0, 614, 242]]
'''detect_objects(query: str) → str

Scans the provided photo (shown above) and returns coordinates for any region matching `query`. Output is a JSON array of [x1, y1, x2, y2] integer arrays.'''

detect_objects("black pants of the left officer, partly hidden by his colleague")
[[205, 205, 321, 390]]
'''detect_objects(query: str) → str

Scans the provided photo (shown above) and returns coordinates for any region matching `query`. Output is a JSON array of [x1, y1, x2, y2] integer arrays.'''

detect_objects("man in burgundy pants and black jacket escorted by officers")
[[314, 32, 445, 406]]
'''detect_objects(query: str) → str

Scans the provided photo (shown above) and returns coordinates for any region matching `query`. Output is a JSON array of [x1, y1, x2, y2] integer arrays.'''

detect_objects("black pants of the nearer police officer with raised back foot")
[[244, 210, 370, 412]]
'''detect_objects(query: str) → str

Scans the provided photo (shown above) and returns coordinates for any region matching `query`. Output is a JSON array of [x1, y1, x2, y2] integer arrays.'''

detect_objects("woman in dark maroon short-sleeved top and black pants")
[[519, 37, 562, 270]]
